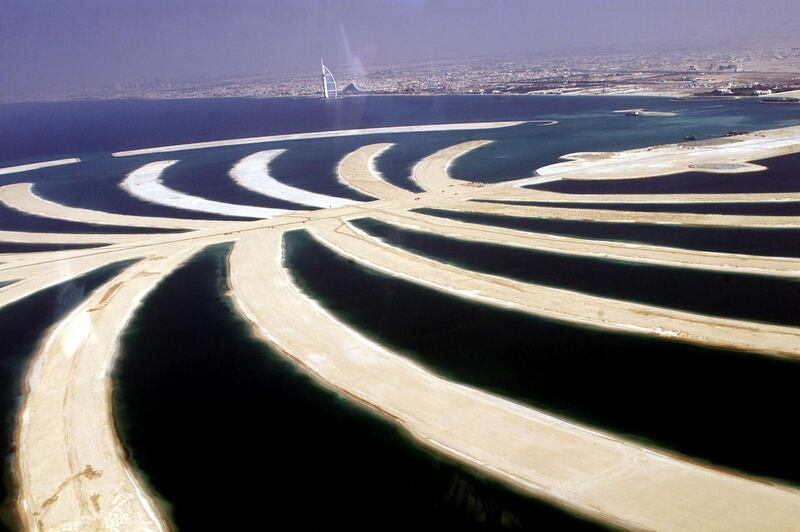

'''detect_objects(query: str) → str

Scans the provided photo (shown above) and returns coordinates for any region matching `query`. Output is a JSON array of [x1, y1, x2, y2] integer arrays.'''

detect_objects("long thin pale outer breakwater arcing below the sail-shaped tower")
[[111, 121, 525, 157]]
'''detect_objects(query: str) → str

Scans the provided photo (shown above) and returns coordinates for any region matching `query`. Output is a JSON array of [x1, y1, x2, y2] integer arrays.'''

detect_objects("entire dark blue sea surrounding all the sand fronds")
[[0, 96, 800, 531]]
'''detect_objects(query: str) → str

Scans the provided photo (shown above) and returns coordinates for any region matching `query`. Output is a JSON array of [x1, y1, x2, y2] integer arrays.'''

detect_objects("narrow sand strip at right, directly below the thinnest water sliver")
[[448, 201, 800, 228]]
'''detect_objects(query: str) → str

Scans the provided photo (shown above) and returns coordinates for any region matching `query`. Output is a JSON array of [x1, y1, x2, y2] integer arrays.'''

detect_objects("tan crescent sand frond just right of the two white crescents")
[[337, 143, 413, 199]]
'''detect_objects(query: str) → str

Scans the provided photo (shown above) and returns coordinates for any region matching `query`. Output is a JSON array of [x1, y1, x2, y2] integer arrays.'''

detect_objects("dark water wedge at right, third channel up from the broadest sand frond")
[[415, 208, 800, 257]]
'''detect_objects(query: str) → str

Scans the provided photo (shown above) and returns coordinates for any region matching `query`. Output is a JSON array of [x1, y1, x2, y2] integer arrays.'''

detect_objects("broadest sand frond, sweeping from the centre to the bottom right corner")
[[230, 232, 800, 530]]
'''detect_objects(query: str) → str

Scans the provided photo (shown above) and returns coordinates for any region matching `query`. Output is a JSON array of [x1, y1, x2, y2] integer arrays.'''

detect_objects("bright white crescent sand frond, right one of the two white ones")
[[230, 150, 358, 209]]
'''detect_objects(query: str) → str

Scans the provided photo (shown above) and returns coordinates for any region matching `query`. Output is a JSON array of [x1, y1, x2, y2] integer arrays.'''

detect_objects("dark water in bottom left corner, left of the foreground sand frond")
[[0, 263, 130, 529]]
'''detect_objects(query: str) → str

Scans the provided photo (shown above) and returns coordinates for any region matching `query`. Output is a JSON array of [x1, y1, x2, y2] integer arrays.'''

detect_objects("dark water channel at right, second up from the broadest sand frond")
[[351, 218, 800, 326]]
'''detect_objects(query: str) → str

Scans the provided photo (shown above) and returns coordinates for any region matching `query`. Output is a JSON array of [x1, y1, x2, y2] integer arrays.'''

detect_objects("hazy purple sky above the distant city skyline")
[[0, 0, 800, 97]]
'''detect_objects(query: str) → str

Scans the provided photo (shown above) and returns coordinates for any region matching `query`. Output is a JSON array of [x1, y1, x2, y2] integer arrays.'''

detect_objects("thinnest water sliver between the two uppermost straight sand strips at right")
[[475, 200, 800, 216]]
